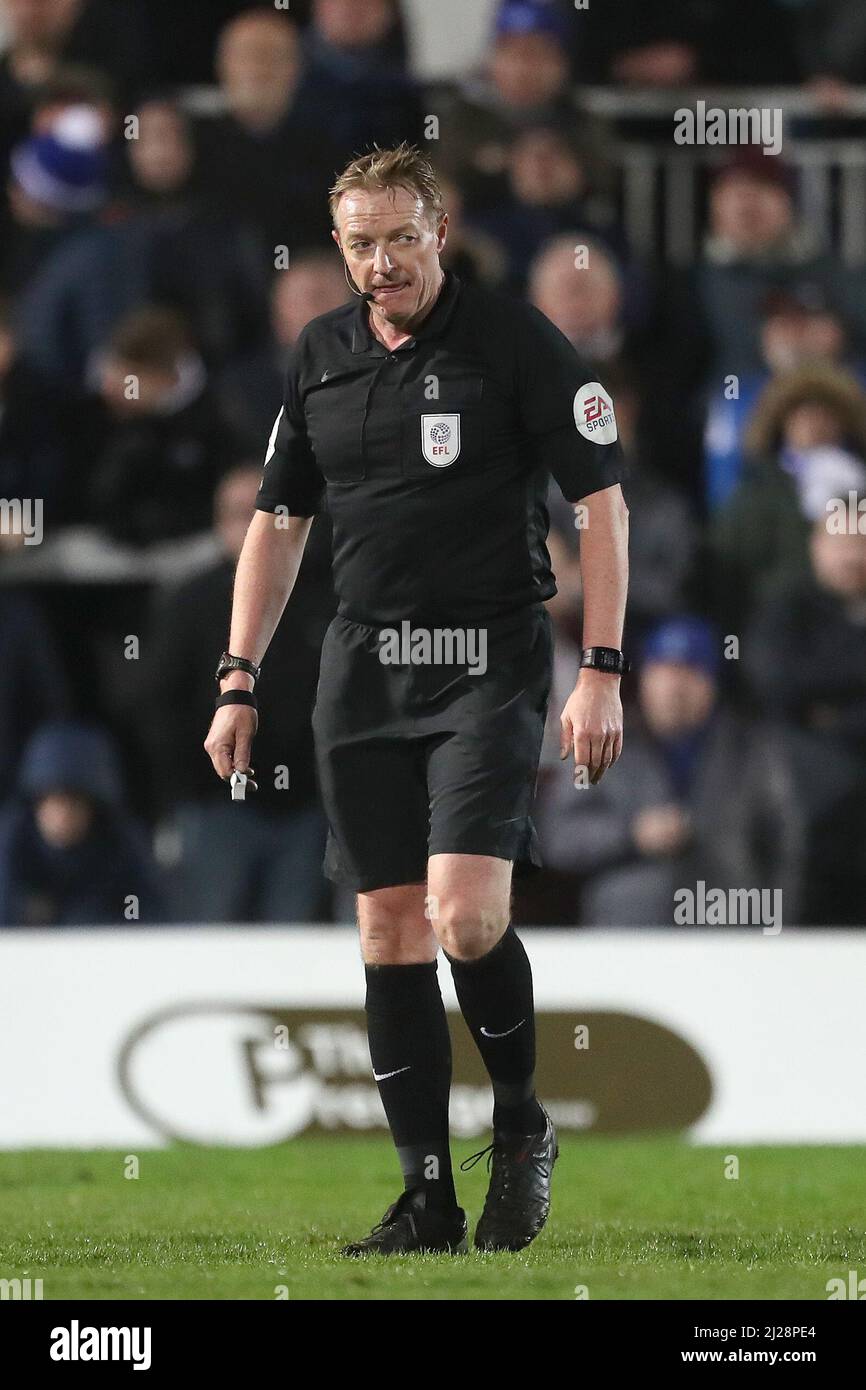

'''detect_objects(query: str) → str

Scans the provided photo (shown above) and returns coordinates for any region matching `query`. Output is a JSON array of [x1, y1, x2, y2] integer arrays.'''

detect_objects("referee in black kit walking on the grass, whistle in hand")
[[204, 145, 627, 1255]]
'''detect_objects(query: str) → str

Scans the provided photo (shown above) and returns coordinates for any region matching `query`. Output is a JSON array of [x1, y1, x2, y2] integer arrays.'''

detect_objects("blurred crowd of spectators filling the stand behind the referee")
[[0, 0, 866, 927]]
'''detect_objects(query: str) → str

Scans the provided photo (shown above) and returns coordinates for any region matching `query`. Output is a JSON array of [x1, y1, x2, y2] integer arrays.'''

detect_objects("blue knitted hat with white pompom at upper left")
[[11, 106, 108, 213]]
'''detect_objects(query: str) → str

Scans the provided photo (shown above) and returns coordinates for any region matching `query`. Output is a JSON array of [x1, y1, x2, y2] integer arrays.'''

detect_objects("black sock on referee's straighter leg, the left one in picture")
[[366, 960, 457, 1211]]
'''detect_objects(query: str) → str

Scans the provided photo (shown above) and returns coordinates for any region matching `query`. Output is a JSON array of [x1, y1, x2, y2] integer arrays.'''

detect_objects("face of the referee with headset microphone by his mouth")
[[334, 188, 448, 328]]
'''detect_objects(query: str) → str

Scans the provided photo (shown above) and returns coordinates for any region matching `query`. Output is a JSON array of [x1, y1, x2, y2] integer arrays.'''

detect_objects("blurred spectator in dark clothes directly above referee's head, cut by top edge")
[[297, 0, 424, 164]]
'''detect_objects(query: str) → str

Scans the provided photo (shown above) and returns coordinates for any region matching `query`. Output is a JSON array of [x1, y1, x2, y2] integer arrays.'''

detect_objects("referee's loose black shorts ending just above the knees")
[[313, 605, 553, 892]]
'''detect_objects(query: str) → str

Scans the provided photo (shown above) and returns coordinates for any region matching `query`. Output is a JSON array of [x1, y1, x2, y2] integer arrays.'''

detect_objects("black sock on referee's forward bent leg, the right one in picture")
[[446, 924, 545, 1134]]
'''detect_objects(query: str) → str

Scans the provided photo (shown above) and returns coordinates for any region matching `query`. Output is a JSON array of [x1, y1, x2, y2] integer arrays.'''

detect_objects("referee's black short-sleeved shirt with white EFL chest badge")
[[257, 271, 624, 627]]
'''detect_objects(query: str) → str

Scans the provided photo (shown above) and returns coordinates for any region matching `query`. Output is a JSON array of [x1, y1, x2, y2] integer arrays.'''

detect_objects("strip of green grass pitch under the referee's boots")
[[0, 1138, 866, 1300]]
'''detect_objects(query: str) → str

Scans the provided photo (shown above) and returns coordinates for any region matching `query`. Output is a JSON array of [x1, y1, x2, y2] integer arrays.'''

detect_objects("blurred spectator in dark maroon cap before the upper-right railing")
[[696, 149, 866, 384]]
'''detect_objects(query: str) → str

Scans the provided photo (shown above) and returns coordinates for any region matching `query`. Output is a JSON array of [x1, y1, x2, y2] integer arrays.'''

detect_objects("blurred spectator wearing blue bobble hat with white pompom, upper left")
[[0, 106, 108, 293]]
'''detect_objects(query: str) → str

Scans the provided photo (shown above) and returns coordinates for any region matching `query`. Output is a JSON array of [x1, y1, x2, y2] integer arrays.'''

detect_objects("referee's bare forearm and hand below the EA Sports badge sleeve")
[[560, 482, 628, 783]]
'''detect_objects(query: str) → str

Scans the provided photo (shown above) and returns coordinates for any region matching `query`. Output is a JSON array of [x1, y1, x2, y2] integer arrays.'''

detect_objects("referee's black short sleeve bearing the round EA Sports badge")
[[517, 306, 626, 502]]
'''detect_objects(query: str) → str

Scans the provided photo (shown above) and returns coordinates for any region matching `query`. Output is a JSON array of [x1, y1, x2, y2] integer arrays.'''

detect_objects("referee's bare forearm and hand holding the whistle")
[[204, 512, 313, 780]]
